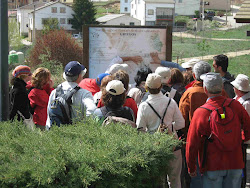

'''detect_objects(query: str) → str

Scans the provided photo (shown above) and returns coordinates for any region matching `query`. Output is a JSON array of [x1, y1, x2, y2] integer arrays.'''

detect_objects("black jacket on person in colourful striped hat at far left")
[[9, 78, 30, 121]]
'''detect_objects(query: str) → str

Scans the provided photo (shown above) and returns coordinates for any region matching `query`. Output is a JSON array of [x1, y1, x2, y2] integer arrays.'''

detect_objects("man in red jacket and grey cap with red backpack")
[[186, 73, 250, 188]]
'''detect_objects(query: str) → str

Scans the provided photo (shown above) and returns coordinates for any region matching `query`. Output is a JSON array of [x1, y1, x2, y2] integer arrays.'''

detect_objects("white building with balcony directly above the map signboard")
[[130, 0, 175, 26]]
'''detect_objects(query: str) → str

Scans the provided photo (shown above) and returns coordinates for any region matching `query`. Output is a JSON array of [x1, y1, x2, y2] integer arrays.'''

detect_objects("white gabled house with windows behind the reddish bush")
[[29, 2, 75, 40]]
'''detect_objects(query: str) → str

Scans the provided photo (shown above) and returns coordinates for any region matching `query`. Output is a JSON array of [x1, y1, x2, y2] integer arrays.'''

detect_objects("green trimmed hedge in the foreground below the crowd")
[[0, 119, 179, 188]]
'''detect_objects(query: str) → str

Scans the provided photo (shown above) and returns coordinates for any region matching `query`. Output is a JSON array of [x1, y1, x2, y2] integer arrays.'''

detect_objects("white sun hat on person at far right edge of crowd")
[[231, 74, 250, 92]]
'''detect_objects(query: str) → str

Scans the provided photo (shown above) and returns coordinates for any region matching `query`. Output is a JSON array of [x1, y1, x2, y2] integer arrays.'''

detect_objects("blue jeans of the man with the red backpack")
[[202, 169, 242, 188]]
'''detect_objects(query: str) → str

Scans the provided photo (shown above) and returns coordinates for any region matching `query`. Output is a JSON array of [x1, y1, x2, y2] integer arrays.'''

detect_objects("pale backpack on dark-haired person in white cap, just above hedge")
[[100, 106, 136, 128]]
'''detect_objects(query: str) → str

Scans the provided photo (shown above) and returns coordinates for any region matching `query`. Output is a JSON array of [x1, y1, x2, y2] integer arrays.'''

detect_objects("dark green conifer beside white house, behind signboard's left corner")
[[72, 0, 98, 31]]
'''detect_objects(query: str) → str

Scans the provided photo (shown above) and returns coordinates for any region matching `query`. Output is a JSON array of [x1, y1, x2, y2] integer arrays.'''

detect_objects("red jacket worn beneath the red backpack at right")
[[186, 96, 250, 173]]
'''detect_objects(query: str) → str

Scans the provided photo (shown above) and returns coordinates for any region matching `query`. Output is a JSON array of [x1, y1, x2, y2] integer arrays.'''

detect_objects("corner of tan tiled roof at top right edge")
[[234, 0, 250, 23]]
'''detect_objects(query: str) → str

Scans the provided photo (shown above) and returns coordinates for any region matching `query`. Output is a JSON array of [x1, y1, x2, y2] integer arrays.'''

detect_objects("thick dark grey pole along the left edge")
[[0, 0, 9, 121]]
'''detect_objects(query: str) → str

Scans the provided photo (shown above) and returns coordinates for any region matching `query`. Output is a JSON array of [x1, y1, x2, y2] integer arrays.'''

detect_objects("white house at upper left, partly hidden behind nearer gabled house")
[[17, 2, 46, 36]]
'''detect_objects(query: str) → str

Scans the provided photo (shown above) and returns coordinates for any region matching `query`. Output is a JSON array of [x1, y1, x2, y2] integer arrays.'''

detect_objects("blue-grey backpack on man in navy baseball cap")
[[49, 85, 80, 127]]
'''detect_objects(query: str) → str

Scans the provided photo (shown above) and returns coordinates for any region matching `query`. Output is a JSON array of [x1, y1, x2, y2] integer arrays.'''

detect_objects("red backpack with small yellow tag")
[[200, 99, 242, 151]]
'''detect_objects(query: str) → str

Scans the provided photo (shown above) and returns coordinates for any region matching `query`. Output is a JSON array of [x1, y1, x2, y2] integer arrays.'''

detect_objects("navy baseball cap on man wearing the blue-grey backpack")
[[64, 61, 87, 77]]
